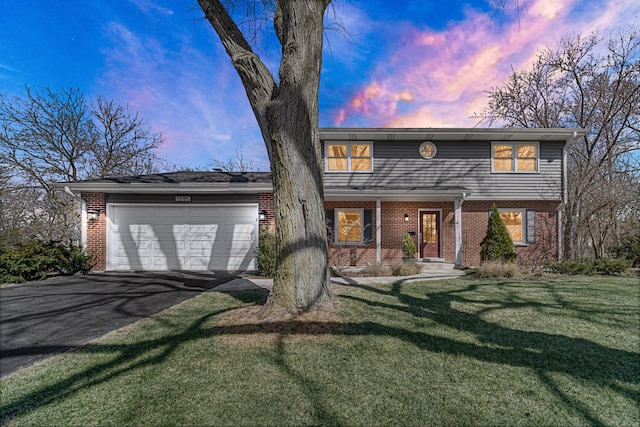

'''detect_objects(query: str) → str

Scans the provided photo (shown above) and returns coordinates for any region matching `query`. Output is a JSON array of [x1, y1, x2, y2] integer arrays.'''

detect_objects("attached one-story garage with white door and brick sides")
[[58, 171, 273, 272]]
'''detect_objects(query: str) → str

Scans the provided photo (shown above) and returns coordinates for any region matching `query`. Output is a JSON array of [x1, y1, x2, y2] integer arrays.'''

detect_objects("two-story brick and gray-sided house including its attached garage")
[[59, 128, 584, 270]]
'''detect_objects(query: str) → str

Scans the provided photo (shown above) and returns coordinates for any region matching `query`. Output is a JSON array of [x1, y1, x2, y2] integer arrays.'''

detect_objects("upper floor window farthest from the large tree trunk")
[[491, 142, 539, 173]]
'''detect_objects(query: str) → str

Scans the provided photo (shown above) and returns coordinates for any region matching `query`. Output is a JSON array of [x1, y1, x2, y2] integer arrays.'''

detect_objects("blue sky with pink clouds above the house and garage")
[[0, 0, 640, 170]]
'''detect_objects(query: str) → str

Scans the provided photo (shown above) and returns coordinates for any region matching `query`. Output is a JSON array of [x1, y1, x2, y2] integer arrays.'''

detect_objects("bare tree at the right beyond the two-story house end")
[[480, 28, 640, 258]]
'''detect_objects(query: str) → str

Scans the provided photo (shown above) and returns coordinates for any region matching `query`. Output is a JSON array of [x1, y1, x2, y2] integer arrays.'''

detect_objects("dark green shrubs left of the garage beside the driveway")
[[0, 241, 91, 283]]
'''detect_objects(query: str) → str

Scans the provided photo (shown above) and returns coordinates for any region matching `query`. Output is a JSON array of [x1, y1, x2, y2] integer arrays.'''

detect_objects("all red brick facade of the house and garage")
[[82, 193, 560, 271]]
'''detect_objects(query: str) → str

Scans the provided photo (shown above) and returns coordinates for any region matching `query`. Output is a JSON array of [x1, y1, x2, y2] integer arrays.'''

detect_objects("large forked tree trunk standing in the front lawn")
[[198, 0, 333, 313]]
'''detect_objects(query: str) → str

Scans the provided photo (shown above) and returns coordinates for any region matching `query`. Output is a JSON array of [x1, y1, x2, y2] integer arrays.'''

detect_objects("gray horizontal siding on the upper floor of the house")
[[325, 141, 564, 200]]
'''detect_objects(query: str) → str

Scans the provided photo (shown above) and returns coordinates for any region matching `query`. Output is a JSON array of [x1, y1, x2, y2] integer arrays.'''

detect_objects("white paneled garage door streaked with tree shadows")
[[107, 204, 258, 271]]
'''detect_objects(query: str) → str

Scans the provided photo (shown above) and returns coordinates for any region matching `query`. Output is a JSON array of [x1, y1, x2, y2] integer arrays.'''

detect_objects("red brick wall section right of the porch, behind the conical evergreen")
[[462, 200, 560, 266]]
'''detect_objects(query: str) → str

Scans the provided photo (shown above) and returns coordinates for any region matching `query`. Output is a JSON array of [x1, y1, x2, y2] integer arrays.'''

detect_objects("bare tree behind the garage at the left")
[[0, 87, 162, 247]]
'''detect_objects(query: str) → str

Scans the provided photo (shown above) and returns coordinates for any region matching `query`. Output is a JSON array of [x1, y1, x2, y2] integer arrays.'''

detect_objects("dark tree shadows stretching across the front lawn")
[[0, 281, 640, 425]]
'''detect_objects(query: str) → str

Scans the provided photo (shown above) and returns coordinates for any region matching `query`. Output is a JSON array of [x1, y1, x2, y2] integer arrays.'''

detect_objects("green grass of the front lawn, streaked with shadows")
[[0, 277, 640, 426]]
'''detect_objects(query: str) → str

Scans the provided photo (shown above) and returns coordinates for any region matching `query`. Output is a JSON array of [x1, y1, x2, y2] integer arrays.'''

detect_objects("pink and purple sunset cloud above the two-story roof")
[[334, 0, 638, 127]]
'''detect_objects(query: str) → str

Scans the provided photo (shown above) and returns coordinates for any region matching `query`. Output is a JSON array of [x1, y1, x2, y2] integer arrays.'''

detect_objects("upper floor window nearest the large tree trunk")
[[326, 142, 373, 172]]
